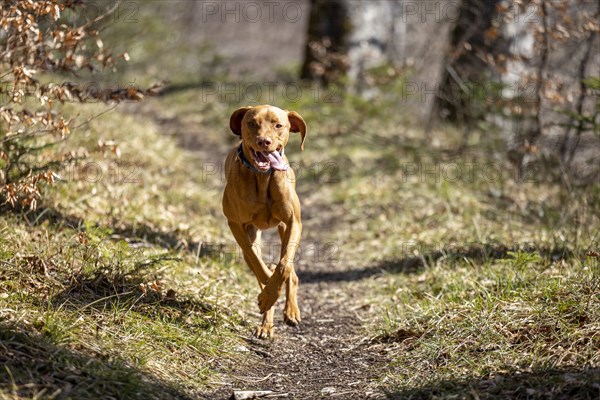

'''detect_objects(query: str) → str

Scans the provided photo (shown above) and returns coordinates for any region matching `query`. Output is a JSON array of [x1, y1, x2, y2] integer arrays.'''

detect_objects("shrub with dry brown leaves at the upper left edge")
[[0, 0, 154, 209]]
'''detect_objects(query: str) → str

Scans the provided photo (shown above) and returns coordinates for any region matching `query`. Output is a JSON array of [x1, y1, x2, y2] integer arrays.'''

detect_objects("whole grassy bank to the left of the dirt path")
[[0, 99, 251, 399]]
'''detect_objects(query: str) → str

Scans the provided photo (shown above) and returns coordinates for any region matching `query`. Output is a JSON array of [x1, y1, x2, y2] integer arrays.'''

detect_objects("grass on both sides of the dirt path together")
[[0, 7, 600, 400]]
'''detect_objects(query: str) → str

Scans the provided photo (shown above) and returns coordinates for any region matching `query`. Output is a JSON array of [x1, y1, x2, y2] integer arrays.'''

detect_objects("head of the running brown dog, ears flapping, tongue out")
[[229, 105, 306, 171]]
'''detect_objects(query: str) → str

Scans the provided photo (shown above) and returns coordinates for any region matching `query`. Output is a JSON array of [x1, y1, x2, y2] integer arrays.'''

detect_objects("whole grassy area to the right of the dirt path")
[[292, 94, 600, 399]]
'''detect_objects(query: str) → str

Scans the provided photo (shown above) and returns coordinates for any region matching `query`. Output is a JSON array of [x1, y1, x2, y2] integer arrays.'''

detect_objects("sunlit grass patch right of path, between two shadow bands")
[[379, 251, 600, 398]]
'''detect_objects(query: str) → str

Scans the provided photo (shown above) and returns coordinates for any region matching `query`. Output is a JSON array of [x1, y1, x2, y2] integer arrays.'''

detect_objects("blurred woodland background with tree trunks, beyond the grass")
[[102, 0, 600, 183]]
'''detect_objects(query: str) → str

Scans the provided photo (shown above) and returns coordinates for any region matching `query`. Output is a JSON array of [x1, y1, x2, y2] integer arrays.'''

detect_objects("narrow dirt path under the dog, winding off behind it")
[[137, 101, 392, 399]]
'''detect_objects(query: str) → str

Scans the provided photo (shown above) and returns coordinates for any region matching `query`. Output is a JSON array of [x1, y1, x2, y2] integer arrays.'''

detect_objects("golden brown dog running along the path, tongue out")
[[223, 105, 306, 338]]
